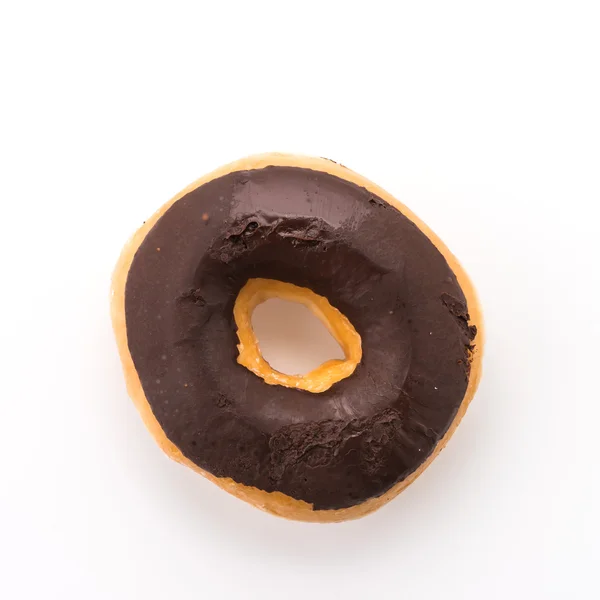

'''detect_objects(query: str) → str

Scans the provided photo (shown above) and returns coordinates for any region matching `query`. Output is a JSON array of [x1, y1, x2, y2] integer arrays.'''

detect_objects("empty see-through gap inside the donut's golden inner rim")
[[251, 298, 345, 375]]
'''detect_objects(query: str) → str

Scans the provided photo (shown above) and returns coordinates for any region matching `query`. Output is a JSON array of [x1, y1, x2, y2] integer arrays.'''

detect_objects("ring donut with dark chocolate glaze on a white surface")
[[111, 154, 483, 522]]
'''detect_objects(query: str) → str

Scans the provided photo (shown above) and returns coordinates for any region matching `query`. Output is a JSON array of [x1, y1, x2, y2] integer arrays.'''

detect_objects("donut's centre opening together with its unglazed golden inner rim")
[[233, 278, 362, 393]]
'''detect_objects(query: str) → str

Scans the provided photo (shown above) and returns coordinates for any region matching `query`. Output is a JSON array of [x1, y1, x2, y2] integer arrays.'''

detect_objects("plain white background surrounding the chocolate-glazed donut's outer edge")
[[0, 0, 600, 600]]
